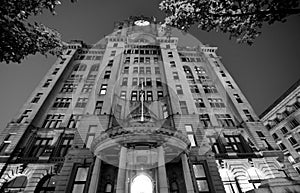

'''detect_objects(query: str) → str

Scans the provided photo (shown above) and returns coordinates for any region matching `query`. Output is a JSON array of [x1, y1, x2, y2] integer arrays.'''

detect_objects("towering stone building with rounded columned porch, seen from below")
[[0, 17, 300, 193]]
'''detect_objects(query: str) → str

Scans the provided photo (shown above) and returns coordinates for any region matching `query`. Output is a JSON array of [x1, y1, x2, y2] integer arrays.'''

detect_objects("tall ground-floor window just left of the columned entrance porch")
[[72, 166, 89, 193]]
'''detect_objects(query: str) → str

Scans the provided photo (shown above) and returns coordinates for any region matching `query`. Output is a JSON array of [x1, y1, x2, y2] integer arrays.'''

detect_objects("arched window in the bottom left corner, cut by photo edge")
[[0, 176, 27, 193]]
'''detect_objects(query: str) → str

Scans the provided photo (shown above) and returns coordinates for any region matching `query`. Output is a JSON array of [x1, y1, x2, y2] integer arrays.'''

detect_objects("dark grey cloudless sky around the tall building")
[[0, 0, 300, 130]]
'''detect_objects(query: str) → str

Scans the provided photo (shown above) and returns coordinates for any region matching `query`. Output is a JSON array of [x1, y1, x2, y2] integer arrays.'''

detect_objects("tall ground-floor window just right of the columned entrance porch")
[[193, 164, 209, 192]]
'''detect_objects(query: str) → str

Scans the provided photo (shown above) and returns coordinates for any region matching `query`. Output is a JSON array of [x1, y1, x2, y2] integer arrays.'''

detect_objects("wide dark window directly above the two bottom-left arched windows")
[[29, 137, 53, 157]]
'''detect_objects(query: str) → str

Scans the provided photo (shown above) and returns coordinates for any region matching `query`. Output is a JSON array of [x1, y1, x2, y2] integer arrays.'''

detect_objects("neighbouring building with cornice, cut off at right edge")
[[260, 80, 300, 174]]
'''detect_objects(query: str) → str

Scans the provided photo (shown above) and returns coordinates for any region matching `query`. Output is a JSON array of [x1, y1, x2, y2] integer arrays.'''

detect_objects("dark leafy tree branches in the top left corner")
[[0, 0, 63, 63]]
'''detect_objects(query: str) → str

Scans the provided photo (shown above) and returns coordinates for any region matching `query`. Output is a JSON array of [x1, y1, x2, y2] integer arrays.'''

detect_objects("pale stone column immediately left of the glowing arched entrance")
[[116, 147, 127, 193]]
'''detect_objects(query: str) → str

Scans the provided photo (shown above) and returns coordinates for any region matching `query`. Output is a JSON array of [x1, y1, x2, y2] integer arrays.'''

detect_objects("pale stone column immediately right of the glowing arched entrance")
[[158, 146, 169, 193]]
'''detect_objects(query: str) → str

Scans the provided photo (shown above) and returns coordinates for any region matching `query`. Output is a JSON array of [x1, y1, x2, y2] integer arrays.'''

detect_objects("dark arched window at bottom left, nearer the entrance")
[[34, 175, 56, 193]]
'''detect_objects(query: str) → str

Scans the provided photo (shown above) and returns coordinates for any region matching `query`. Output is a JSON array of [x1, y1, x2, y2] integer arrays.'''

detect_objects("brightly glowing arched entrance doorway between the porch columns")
[[130, 174, 153, 193]]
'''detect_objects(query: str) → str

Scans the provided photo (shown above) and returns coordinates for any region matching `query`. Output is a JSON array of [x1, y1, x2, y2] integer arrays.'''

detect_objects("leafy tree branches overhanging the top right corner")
[[160, 0, 300, 45]]
